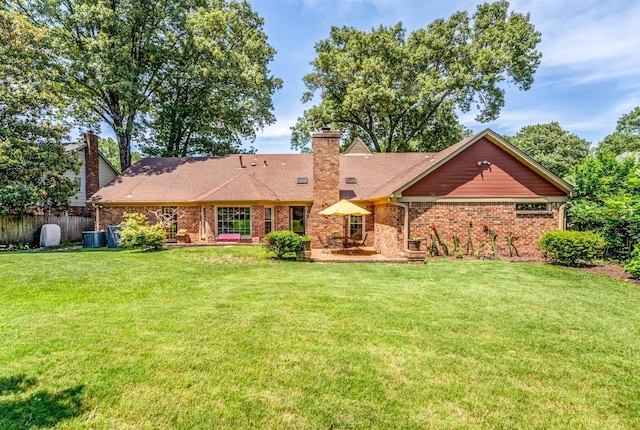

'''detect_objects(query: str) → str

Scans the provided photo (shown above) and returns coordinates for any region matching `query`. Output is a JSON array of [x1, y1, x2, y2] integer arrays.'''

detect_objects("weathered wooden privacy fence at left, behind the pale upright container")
[[0, 215, 95, 245]]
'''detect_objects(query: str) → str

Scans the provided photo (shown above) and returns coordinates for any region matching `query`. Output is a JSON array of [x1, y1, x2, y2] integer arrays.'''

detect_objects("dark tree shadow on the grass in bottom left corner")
[[0, 375, 84, 430]]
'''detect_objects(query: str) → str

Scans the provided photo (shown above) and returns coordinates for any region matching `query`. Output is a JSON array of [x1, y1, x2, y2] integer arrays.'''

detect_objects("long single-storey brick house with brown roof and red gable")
[[91, 128, 571, 257]]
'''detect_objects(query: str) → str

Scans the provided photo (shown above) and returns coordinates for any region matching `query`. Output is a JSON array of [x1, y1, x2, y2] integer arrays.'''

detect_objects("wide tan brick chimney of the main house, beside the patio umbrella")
[[307, 127, 343, 247]]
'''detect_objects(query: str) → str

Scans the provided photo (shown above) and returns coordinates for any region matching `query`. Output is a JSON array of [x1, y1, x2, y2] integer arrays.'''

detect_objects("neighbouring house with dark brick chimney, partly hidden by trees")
[[64, 131, 118, 217]]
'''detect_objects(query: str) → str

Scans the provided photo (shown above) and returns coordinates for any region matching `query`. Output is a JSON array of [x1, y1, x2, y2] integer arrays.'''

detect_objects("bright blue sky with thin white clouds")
[[249, 0, 640, 154]]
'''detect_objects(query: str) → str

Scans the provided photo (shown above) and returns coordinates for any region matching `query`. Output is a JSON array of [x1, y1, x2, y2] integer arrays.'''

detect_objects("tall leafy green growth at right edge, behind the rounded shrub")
[[567, 151, 640, 260]]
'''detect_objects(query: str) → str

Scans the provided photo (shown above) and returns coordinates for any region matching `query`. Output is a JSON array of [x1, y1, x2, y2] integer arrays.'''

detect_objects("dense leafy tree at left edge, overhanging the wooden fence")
[[0, 9, 79, 215]]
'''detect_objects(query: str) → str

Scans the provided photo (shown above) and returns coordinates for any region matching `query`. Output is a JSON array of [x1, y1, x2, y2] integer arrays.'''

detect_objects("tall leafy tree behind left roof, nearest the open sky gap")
[[143, 3, 281, 156]]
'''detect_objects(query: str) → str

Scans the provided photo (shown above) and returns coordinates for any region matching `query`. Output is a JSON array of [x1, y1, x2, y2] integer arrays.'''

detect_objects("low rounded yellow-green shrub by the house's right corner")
[[538, 231, 604, 267]]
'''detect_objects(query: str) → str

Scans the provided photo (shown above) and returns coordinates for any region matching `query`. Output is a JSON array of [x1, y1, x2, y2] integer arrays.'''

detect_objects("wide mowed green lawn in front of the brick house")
[[0, 247, 640, 429]]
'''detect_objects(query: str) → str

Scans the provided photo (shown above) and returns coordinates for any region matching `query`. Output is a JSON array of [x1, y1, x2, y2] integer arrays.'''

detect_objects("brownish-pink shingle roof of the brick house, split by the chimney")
[[92, 130, 568, 204]]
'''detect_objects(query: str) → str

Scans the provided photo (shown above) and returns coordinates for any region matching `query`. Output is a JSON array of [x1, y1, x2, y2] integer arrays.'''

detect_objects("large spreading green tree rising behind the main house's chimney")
[[292, 1, 541, 152]]
